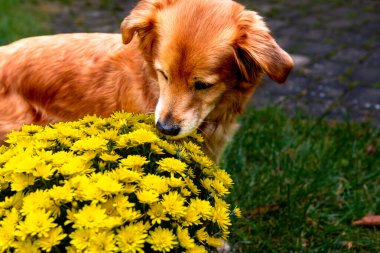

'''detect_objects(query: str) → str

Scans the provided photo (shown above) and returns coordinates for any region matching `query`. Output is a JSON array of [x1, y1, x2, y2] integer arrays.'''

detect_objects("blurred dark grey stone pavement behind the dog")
[[49, 0, 380, 126]]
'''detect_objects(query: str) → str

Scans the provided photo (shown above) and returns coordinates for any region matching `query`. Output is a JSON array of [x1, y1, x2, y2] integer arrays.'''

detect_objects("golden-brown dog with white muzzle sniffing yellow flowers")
[[0, 0, 293, 161]]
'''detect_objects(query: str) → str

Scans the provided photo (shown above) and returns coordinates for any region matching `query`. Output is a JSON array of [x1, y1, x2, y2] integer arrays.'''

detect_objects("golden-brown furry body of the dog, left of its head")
[[0, 33, 156, 139]]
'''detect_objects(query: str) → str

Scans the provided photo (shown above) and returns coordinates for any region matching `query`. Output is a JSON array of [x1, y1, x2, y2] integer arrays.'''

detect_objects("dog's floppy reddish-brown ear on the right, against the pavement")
[[234, 10, 294, 83]]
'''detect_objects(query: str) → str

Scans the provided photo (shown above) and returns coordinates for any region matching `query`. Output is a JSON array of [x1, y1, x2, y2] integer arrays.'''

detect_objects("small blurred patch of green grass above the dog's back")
[[0, 0, 50, 45]]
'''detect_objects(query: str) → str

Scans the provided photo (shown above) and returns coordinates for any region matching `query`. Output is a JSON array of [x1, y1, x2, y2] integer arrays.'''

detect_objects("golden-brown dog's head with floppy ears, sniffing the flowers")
[[121, 0, 293, 137]]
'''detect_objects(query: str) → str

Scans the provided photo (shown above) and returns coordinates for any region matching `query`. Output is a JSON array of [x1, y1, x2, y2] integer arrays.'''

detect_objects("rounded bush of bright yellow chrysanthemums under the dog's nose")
[[0, 113, 240, 252]]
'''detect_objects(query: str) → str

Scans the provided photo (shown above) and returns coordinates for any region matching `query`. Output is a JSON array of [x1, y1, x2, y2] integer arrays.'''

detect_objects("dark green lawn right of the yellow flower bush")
[[222, 108, 380, 252]]
